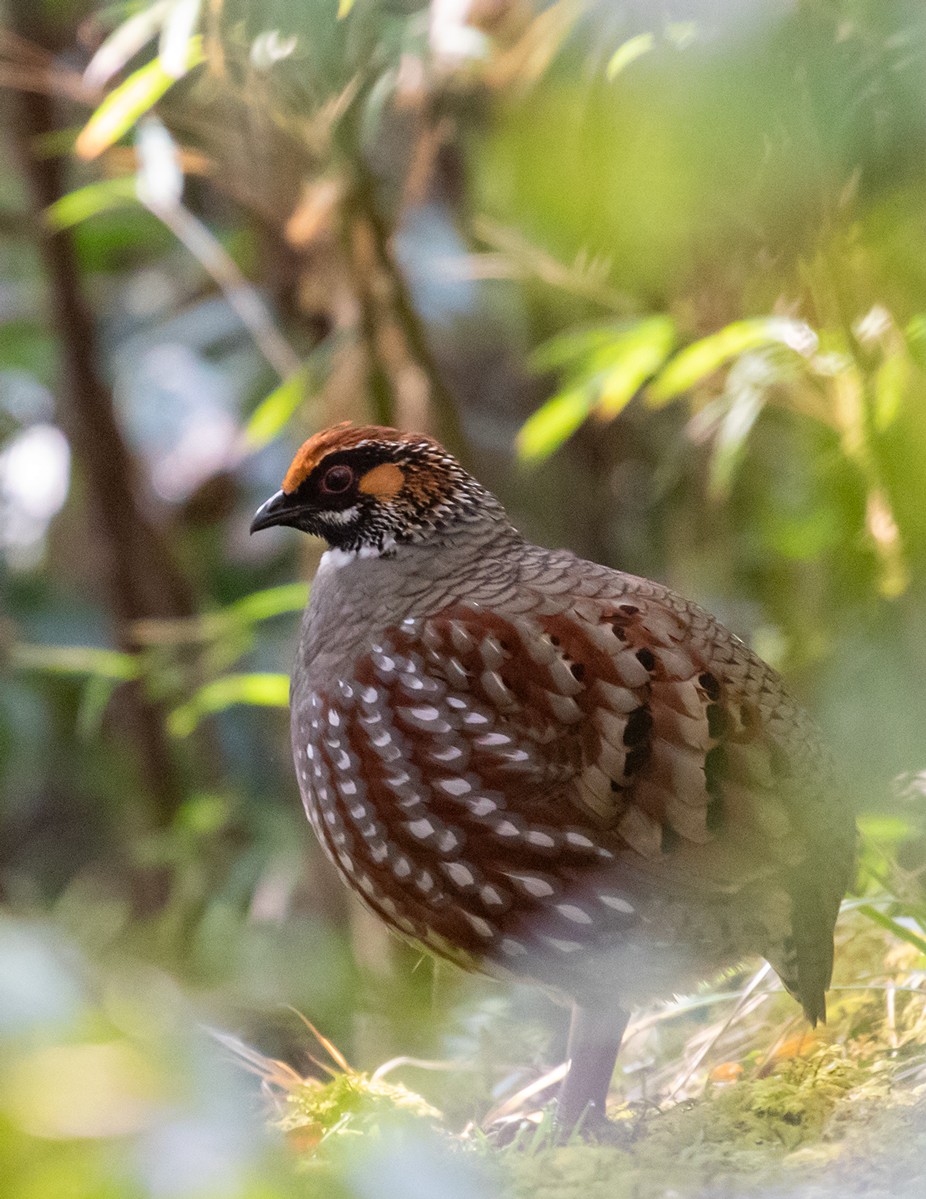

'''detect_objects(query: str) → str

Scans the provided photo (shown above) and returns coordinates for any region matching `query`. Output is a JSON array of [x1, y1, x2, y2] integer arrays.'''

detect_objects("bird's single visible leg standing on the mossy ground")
[[557, 1004, 630, 1133]]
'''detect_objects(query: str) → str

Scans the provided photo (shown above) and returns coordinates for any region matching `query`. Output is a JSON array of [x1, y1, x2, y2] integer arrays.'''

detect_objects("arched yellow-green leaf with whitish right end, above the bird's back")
[[647, 317, 818, 408]]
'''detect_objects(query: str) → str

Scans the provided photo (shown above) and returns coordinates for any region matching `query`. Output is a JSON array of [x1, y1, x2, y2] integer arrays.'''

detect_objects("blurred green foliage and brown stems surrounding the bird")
[[0, 0, 926, 1199]]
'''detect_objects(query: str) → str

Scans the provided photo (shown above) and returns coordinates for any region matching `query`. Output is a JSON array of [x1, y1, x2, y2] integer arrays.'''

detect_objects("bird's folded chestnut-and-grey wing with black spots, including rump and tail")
[[393, 589, 853, 1020]]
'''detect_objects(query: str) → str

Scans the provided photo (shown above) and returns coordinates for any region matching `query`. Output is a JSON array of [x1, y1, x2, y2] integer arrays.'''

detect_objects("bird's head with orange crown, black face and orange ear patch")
[[251, 422, 505, 556]]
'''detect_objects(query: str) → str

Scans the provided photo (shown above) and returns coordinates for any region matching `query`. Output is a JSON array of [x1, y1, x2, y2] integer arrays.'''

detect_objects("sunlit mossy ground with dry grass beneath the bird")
[[263, 912, 926, 1199]]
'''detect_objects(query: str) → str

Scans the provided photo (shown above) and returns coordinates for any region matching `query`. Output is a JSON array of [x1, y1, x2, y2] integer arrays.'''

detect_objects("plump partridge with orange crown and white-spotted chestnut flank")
[[251, 422, 855, 1132]]
